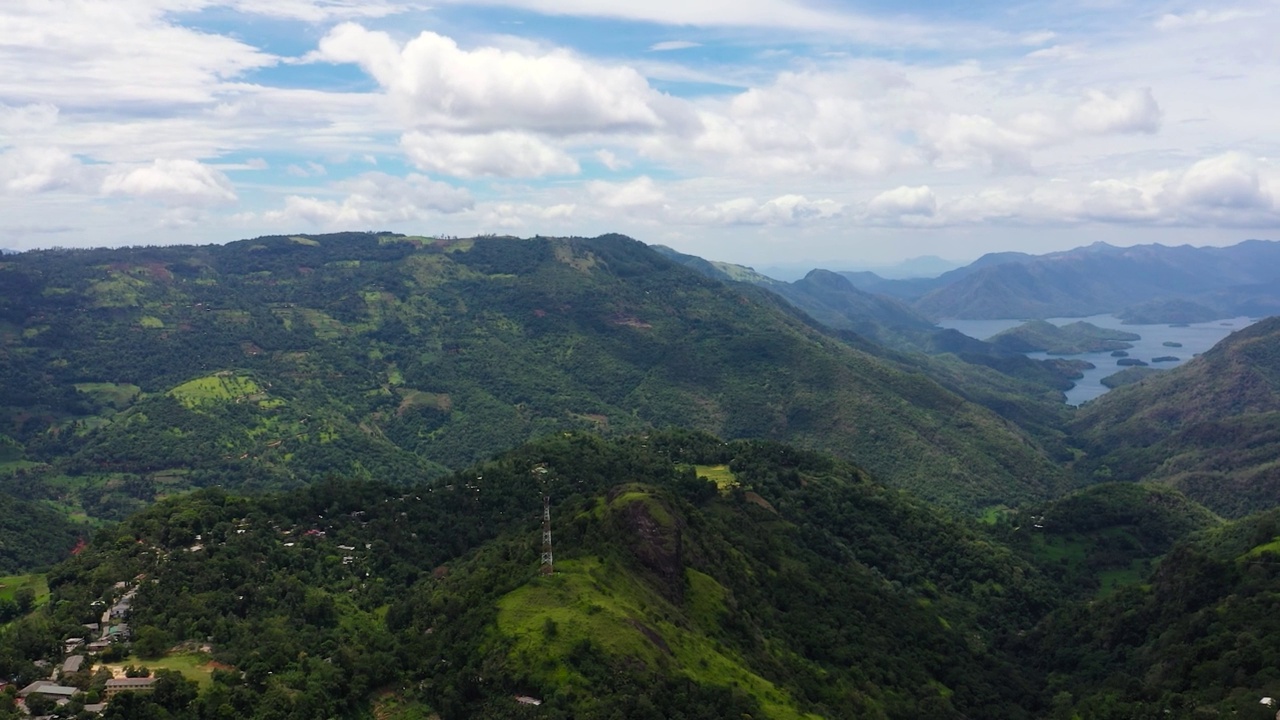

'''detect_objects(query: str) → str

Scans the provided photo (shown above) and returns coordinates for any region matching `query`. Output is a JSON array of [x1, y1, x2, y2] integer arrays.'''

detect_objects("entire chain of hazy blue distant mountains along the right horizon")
[[680, 240, 1280, 322]]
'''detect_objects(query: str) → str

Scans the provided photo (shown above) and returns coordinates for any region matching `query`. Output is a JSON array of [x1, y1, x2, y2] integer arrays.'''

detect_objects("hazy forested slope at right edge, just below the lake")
[[1073, 318, 1280, 516]]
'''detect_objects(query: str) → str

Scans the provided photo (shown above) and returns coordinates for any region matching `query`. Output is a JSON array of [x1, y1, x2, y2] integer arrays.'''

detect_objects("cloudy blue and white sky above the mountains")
[[0, 0, 1280, 268]]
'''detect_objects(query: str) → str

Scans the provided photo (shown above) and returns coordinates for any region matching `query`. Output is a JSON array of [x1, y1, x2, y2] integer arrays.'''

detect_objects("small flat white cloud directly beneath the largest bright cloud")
[[401, 131, 579, 178]]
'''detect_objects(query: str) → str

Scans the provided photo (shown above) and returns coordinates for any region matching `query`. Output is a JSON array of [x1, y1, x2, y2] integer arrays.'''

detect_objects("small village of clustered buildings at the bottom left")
[[0, 582, 156, 720]]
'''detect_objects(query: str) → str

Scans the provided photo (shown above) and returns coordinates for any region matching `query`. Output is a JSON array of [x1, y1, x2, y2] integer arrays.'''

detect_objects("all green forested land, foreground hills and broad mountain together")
[[0, 233, 1280, 720]]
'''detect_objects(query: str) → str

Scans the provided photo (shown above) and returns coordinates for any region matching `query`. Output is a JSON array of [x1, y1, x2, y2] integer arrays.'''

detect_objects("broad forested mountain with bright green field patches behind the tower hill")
[[0, 233, 1068, 518]]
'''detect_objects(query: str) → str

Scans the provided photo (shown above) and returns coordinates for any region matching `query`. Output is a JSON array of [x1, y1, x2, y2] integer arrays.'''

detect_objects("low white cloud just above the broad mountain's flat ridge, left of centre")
[[262, 172, 474, 228]]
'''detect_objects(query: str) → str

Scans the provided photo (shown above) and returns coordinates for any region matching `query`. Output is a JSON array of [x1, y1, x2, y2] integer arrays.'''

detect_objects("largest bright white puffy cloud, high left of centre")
[[310, 23, 680, 133]]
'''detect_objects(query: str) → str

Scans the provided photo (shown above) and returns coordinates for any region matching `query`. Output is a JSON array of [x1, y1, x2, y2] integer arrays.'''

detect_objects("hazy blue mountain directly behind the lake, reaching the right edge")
[[911, 240, 1280, 317]]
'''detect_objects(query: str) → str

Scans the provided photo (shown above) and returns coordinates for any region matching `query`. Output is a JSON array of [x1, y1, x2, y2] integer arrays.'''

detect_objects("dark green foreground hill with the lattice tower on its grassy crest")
[[0, 433, 1055, 719]]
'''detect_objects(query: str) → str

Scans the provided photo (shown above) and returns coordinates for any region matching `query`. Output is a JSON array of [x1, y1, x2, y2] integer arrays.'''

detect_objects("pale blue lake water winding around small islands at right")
[[938, 315, 1257, 405]]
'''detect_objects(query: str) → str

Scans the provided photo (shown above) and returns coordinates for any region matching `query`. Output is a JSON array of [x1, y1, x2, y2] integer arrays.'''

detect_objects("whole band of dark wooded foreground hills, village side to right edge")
[[0, 432, 1280, 720]]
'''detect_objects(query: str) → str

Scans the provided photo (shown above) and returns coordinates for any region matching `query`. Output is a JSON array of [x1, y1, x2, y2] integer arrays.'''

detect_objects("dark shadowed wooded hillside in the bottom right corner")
[[1025, 510, 1280, 720]]
